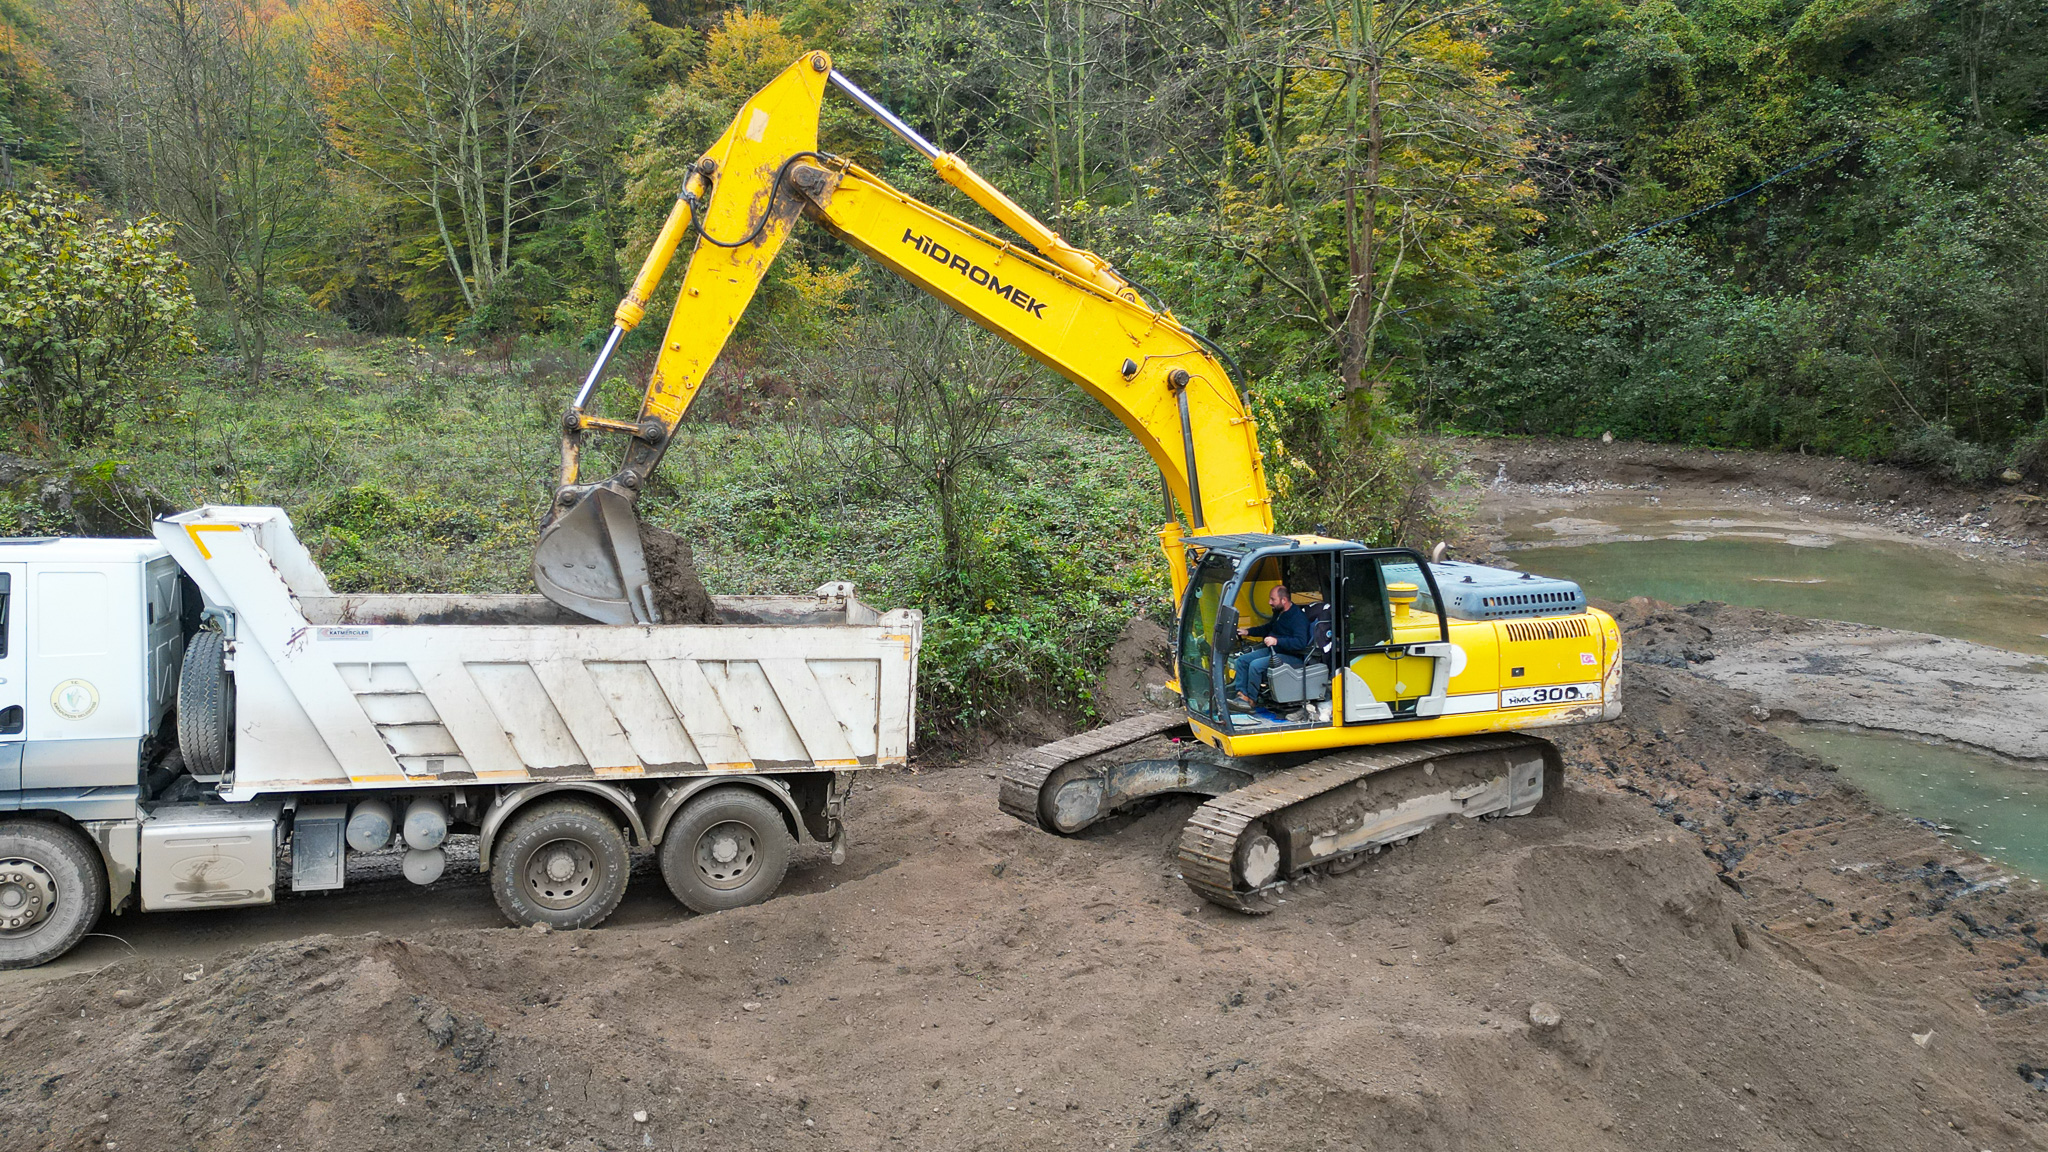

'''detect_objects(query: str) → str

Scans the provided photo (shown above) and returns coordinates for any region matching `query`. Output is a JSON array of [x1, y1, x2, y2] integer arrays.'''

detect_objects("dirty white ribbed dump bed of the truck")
[[156, 506, 922, 799]]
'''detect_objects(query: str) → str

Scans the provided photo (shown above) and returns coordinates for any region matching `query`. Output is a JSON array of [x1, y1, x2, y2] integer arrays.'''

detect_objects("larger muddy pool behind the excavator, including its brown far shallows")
[[1503, 502, 2048, 654]]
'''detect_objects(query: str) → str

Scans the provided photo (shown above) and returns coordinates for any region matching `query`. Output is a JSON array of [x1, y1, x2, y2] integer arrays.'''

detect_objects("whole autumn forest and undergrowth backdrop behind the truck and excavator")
[[0, 0, 2048, 725]]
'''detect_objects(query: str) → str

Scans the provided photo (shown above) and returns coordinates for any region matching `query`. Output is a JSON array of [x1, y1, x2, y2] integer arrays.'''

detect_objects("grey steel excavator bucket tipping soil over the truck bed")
[[532, 484, 662, 623]]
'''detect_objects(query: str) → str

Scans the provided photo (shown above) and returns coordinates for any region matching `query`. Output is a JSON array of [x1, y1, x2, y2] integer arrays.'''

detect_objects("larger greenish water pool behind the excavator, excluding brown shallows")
[[1516, 535, 2048, 654]]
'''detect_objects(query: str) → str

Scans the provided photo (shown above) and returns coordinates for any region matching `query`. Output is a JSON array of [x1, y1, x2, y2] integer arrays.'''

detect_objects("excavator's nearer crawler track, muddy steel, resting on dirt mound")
[[1180, 734, 1563, 914]]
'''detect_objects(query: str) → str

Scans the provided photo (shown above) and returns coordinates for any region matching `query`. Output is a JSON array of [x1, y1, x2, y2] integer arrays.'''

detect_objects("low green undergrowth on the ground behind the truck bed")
[[103, 334, 1169, 734]]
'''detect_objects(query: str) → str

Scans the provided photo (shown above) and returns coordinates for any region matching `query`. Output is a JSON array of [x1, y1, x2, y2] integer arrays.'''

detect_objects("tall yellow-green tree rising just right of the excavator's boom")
[[1219, 0, 1540, 401]]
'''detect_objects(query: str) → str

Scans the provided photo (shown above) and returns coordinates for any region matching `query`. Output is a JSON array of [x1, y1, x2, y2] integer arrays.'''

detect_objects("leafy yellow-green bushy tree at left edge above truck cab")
[[0, 189, 195, 447]]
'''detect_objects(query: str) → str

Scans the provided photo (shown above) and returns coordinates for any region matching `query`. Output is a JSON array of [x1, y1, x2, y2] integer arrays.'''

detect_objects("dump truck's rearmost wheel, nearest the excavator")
[[662, 787, 797, 912]]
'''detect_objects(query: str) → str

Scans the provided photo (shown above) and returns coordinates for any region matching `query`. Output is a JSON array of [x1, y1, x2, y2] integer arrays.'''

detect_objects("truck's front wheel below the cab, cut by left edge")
[[0, 820, 106, 968]]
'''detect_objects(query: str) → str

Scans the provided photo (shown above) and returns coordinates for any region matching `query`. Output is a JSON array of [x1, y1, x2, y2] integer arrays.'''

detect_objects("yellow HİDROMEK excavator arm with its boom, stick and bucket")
[[535, 51, 1274, 623]]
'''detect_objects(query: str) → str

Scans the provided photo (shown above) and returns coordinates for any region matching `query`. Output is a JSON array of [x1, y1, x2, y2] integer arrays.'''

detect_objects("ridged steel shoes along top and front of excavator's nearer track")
[[1180, 734, 1544, 916]]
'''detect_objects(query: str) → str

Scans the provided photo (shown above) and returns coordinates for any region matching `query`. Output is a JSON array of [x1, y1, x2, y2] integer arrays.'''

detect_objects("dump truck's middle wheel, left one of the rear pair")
[[492, 799, 633, 931]]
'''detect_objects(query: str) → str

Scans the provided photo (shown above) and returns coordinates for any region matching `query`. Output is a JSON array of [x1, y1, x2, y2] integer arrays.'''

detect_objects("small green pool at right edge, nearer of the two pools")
[[1774, 726, 2048, 879]]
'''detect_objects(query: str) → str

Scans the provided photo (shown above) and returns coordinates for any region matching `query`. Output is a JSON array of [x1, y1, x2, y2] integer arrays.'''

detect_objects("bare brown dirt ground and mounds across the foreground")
[[0, 614, 2048, 1152]]
